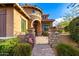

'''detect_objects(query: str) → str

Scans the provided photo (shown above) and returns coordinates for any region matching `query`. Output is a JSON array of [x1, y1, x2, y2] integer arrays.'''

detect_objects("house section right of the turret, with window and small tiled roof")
[[41, 14, 54, 32]]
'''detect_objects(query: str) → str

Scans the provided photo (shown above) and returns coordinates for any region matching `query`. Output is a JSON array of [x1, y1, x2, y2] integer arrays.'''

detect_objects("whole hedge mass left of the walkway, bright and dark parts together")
[[0, 38, 31, 56]]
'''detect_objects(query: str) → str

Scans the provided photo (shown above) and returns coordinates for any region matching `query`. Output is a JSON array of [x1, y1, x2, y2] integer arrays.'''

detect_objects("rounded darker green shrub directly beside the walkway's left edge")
[[13, 43, 32, 56]]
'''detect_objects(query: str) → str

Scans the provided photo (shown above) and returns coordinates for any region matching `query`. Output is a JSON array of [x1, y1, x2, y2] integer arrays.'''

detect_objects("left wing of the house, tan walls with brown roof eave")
[[0, 4, 30, 37]]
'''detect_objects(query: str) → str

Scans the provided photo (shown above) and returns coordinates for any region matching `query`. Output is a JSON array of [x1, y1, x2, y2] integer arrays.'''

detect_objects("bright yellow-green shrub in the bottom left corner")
[[0, 38, 18, 56]]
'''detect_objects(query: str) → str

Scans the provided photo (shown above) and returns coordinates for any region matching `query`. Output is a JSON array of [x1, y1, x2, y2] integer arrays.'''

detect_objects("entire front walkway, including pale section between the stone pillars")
[[32, 36, 55, 56]]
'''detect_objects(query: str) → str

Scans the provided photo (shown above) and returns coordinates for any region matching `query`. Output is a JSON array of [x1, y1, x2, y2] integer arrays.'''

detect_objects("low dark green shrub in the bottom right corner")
[[56, 44, 79, 56]]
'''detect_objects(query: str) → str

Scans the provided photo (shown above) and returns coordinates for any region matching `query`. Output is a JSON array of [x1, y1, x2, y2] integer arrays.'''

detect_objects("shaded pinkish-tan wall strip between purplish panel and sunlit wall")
[[6, 7, 13, 36]]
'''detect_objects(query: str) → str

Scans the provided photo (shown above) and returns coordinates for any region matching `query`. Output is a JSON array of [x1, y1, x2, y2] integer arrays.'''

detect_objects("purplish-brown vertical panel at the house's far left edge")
[[0, 7, 6, 37]]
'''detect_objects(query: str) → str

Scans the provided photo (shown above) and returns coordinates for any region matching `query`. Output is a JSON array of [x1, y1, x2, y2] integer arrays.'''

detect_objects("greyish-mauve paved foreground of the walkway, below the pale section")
[[32, 44, 54, 56]]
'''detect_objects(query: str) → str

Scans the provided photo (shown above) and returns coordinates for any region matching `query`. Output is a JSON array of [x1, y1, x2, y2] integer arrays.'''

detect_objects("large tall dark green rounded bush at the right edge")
[[68, 17, 79, 42]]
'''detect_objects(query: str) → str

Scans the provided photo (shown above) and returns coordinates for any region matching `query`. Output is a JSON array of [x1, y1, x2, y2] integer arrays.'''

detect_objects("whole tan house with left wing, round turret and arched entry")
[[0, 3, 53, 37]]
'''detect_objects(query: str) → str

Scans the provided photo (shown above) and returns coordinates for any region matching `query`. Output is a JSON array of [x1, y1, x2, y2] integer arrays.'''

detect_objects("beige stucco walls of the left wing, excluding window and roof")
[[0, 6, 28, 37]]
